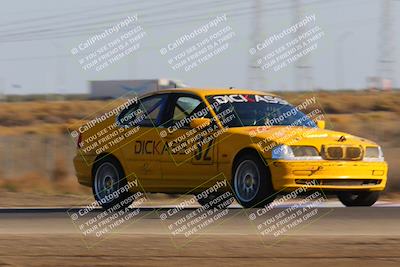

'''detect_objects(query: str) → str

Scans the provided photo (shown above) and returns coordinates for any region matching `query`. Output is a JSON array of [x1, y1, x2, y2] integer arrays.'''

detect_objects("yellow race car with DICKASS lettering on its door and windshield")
[[74, 88, 387, 208]]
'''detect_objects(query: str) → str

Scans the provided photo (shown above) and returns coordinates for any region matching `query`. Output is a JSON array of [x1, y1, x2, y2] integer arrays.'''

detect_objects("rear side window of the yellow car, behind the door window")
[[118, 94, 167, 127]]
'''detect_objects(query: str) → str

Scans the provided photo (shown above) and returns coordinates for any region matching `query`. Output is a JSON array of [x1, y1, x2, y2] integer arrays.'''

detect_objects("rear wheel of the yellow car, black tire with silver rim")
[[92, 157, 133, 210]]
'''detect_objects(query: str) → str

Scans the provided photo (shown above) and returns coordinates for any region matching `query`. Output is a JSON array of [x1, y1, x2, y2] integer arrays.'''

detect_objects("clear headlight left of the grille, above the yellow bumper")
[[272, 145, 322, 160]]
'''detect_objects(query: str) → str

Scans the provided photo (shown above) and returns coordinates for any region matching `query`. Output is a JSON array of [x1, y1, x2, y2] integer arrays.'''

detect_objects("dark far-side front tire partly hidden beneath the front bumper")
[[337, 191, 379, 207]]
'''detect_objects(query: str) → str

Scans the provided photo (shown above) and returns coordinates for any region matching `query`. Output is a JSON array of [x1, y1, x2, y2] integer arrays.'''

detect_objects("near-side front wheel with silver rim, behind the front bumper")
[[232, 154, 275, 208]]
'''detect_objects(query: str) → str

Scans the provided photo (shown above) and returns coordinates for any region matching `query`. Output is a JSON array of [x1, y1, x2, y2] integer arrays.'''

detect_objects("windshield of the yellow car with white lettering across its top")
[[206, 94, 316, 128]]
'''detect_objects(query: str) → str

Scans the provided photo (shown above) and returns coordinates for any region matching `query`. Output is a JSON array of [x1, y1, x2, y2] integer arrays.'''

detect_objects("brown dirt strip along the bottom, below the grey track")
[[0, 235, 400, 267]]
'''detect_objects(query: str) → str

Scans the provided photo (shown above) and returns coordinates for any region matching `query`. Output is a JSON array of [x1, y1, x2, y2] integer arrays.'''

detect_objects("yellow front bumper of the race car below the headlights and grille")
[[268, 160, 388, 191]]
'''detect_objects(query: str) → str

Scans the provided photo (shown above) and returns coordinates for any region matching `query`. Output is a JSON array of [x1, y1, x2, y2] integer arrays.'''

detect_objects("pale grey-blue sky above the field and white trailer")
[[0, 0, 400, 94]]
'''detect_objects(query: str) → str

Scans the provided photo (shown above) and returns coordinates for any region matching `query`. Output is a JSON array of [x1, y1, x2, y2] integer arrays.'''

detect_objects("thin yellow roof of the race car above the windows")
[[145, 88, 275, 96]]
